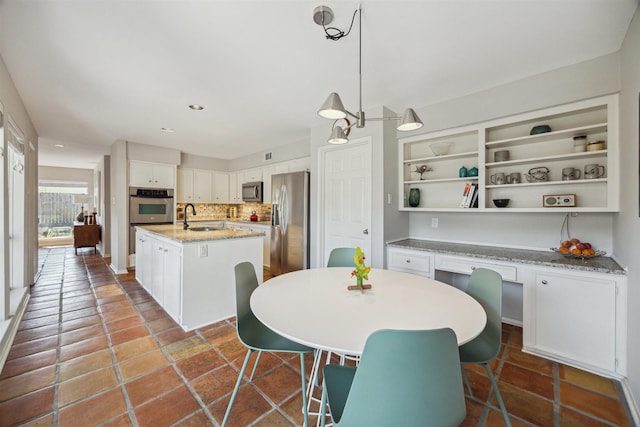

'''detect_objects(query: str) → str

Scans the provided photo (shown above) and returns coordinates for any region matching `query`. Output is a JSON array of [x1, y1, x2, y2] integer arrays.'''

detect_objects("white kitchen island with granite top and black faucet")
[[136, 224, 263, 331]]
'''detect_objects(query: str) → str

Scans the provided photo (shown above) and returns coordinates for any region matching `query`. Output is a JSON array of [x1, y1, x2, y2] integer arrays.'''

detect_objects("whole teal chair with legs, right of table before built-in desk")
[[460, 268, 511, 427]]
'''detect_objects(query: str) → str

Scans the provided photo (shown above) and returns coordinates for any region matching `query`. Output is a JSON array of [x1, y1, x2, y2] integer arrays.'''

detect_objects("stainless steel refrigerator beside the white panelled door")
[[270, 171, 309, 275]]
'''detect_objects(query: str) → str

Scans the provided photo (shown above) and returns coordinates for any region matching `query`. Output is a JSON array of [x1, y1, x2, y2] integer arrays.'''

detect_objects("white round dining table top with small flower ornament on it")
[[251, 267, 487, 355]]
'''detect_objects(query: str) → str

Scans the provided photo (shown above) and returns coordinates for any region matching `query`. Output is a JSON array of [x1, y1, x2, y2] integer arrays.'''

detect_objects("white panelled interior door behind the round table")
[[319, 138, 371, 265]]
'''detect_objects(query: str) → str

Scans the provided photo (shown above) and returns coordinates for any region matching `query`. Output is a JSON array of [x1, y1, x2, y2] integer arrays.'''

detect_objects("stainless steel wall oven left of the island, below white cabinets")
[[129, 187, 175, 254]]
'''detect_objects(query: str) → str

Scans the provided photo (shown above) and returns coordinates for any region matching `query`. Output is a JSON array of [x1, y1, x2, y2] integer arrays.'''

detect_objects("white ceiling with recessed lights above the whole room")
[[0, 0, 638, 168]]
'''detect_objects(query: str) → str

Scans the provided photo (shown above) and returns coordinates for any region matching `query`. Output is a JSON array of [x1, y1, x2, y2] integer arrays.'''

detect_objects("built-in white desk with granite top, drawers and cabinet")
[[387, 239, 627, 378]]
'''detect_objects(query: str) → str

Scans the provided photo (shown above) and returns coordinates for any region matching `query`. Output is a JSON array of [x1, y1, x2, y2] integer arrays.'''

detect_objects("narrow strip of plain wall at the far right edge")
[[613, 5, 640, 422]]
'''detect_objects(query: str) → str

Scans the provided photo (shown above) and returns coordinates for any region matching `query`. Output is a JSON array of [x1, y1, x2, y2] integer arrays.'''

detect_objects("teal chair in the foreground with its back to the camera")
[[321, 328, 466, 427]]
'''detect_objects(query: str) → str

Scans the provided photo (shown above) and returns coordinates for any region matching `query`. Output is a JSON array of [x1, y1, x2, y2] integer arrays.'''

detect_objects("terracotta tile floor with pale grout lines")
[[0, 248, 630, 426]]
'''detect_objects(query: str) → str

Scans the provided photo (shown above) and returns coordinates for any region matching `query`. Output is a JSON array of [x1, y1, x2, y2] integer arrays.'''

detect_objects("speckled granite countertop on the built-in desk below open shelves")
[[387, 239, 627, 275]]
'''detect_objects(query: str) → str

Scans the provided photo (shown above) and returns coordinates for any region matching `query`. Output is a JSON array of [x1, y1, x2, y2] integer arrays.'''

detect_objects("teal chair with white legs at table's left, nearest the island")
[[222, 262, 314, 426]]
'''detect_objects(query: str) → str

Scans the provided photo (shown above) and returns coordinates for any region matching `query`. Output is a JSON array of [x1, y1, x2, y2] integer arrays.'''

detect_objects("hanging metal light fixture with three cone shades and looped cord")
[[313, 5, 423, 144]]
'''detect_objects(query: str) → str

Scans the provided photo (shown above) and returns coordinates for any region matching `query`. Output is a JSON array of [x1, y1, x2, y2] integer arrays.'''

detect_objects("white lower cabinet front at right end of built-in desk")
[[523, 268, 626, 375]]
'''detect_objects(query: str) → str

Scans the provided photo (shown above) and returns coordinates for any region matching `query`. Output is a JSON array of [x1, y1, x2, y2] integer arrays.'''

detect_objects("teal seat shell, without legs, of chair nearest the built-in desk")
[[465, 268, 502, 362]]
